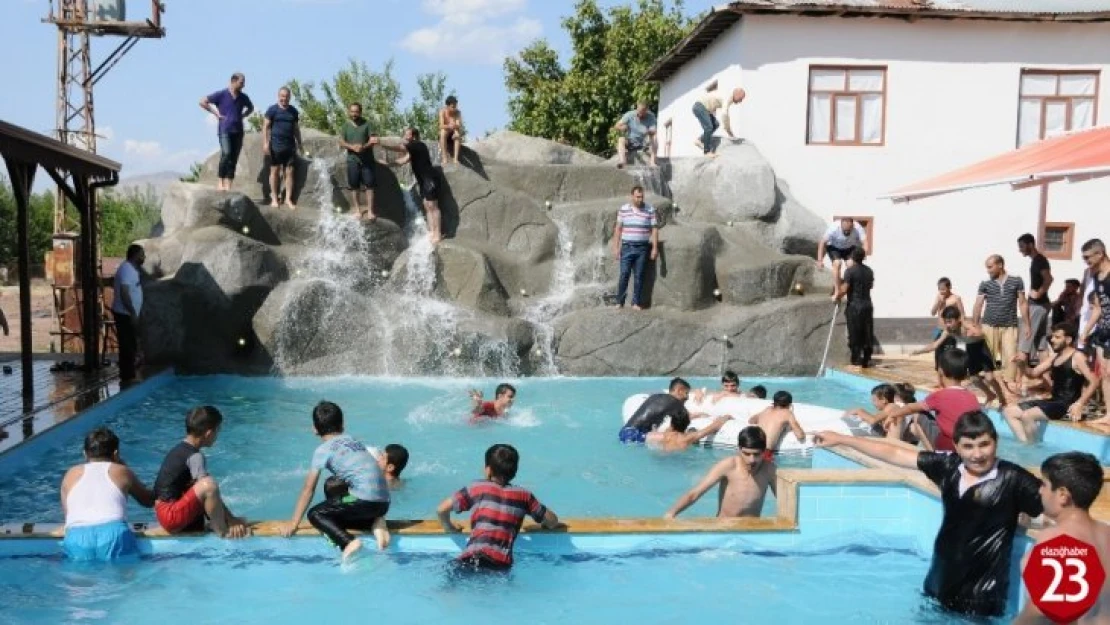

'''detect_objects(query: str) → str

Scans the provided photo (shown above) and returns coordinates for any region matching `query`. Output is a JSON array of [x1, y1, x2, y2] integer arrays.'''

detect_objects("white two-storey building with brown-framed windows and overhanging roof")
[[648, 0, 1110, 317]]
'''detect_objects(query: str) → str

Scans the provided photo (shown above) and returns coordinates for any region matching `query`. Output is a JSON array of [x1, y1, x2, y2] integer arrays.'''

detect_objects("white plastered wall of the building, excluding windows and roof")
[[659, 16, 1110, 317]]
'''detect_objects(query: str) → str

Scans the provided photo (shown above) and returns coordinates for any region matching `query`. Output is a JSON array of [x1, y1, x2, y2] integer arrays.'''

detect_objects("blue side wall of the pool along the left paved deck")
[[0, 371, 175, 474]]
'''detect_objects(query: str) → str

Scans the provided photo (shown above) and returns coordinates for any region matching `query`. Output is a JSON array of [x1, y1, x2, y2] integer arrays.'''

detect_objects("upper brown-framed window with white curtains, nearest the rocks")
[[806, 65, 887, 145]]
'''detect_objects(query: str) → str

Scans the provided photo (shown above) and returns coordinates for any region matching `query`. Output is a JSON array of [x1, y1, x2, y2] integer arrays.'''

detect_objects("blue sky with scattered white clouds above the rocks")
[[0, 0, 722, 178]]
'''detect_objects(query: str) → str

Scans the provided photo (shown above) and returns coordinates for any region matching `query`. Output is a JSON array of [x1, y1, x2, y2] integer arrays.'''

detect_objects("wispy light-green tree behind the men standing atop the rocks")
[[284, 59, 447, 137]]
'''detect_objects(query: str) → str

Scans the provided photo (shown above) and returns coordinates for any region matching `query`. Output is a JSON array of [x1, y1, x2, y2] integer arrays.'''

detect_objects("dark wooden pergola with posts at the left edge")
[[0, 120, 120, 412]]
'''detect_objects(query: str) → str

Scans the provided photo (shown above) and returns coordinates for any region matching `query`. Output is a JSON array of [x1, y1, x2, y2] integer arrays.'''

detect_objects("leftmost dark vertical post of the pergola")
[[4, 155, 38, 414]]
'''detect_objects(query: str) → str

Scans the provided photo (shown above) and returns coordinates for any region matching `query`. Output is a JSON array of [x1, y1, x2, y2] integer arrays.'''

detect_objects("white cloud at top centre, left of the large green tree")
[[401, 0, 543, 64]]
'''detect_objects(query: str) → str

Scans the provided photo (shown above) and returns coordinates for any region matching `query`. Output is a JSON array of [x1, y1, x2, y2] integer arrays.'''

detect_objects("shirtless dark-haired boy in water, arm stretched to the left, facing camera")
[[663, 425, 778, 520]]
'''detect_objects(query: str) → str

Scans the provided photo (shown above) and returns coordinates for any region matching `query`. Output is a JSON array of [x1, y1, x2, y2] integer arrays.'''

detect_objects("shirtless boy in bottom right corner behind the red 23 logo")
[[1013, 452, 1110, 625]]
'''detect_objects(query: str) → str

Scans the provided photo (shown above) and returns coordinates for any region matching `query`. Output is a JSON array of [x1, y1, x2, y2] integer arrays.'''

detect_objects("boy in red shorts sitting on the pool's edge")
[[154, 406, 251, 538]]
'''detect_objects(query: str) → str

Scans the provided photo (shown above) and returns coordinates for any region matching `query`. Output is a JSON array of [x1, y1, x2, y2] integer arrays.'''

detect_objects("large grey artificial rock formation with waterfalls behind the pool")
[[132, 131, 845, 375]]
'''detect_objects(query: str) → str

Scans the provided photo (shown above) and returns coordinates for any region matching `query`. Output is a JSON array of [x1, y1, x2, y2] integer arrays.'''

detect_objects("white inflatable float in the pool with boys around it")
[[620, 393, 864, 452]]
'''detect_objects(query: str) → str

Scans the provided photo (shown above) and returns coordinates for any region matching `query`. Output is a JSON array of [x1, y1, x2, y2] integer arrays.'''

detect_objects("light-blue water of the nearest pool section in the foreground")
[[0, 536, 1007, 625]]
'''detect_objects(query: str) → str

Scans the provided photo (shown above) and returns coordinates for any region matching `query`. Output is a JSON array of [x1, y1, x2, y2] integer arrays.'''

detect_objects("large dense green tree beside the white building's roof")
[[504, 0, 697, 154]]
